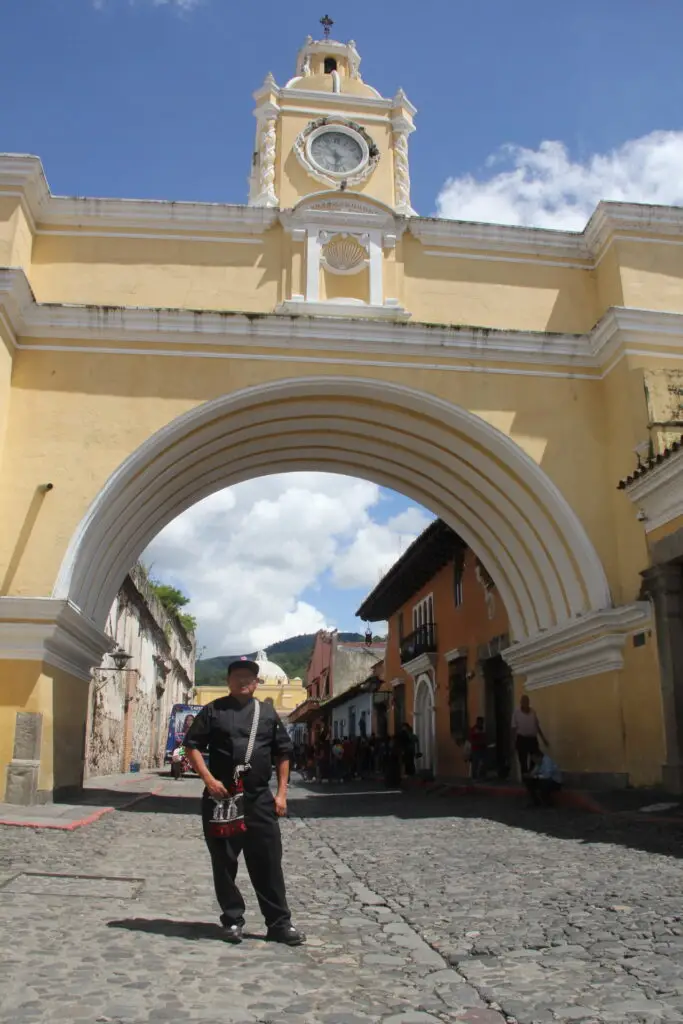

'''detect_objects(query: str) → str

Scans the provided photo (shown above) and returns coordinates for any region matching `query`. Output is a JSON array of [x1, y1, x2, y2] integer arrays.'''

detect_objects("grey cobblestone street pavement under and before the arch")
[[0, 779, 683, 1024]]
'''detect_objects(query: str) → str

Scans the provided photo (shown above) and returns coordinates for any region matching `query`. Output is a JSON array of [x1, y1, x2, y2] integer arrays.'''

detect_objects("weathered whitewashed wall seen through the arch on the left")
[[85, 567, 196, 777]]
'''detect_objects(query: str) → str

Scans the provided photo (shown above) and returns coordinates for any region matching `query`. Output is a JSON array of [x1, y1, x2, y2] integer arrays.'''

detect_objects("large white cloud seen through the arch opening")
[[142, 473, 429, 655]]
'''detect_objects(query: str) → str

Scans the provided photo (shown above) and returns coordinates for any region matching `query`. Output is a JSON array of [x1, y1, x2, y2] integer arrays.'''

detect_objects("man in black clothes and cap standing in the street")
[[185, 658, 305, 946]]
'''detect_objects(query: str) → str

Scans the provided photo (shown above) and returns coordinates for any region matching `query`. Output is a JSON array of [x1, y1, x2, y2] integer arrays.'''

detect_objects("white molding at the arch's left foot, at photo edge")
[[0, 597, 114, 680]]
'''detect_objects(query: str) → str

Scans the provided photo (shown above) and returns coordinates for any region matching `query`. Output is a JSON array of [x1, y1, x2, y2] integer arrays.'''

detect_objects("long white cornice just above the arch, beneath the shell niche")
[[0, 267, 683, 379]]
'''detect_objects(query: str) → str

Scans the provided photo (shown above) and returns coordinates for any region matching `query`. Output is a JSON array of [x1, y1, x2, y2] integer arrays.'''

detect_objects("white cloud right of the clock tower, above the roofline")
[[436, 131, 683, 230]]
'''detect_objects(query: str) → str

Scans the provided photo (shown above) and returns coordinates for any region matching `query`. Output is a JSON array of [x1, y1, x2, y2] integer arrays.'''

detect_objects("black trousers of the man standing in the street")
[[202, 793, 292, 929]]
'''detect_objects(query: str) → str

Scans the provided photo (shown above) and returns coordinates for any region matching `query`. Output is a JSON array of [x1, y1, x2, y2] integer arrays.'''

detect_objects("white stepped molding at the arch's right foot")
[[501, 601, 651, 690]]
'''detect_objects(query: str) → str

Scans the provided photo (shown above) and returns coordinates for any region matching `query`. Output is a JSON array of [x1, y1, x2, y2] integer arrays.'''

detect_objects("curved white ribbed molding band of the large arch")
[[53, 376, 611, 640]]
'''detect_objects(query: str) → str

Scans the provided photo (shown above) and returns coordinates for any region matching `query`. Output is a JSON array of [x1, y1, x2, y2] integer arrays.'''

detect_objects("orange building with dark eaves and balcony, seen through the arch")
[[357, 519, 514, 777]]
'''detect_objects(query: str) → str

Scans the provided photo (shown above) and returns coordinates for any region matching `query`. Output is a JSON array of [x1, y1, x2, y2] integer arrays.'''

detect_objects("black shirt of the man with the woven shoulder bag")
[[185, 696, 292, 800]]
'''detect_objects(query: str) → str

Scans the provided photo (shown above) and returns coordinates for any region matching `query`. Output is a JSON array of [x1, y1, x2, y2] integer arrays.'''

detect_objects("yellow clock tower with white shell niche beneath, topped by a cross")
[[249, 27, 416, 319]]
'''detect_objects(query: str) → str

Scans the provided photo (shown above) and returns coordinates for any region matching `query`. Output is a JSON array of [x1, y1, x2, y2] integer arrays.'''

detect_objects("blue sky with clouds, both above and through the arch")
[[5, 0, 683, 653]]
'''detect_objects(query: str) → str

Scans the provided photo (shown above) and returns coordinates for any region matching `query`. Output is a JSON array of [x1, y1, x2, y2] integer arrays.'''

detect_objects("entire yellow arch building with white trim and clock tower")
[[0, 29, 683, 801]]
